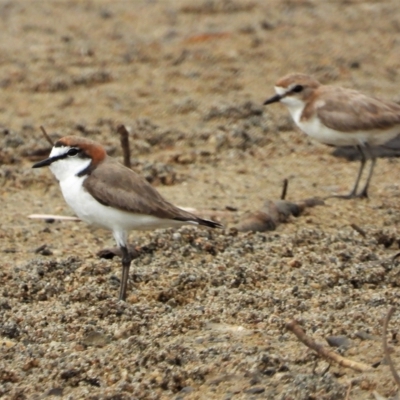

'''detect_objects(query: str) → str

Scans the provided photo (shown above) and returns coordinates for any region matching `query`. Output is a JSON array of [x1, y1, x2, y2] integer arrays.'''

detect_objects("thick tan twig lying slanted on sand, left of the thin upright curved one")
[[286, 320, 373, 372]]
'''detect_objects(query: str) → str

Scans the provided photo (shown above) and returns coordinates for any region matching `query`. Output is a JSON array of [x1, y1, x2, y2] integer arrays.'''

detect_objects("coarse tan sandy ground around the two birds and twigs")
[[0, 0, 400, 400]]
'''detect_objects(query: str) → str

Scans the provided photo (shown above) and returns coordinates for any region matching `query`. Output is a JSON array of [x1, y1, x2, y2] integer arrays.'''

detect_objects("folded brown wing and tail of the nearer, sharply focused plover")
[[83, 157, 223, 227]]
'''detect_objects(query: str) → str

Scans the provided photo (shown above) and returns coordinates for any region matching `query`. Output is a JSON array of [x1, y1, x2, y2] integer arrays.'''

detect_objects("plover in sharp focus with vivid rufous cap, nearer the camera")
[[33, 136, 222, 300]]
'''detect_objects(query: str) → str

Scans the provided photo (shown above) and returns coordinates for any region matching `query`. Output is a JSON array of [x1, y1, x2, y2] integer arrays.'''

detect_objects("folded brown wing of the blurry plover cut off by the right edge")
[[315, 86, 400, 132]]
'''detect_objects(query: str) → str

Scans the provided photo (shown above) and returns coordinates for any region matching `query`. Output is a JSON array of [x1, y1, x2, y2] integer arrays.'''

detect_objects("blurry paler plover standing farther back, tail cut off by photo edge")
[[264, 74, 400, 199]]
